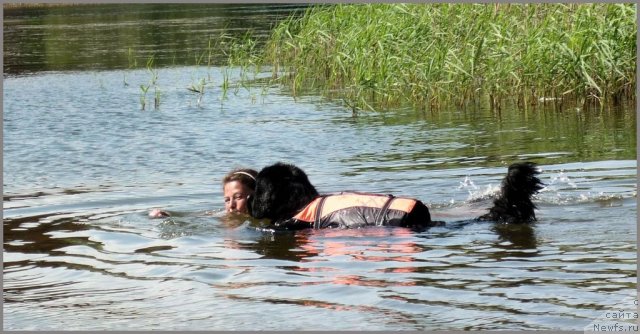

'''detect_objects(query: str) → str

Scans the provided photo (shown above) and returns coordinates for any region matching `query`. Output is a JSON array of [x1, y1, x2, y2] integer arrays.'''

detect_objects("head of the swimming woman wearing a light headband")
[[222, 168, 258, 213]]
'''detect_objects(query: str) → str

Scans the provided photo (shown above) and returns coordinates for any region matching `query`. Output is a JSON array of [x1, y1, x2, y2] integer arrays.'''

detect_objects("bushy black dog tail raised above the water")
[[478, 162, 544, 223]]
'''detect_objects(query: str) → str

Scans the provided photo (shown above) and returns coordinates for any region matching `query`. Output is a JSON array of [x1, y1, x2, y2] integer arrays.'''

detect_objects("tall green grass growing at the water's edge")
[[260, 3, 637, 109]]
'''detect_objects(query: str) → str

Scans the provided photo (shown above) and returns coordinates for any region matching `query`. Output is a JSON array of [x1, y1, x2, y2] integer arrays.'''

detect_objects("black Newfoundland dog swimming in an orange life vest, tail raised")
[[249, 162, 542, 230]]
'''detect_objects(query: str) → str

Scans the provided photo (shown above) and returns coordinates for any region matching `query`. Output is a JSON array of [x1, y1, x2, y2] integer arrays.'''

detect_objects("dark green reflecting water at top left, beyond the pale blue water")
[[3, 4, 305, 75]]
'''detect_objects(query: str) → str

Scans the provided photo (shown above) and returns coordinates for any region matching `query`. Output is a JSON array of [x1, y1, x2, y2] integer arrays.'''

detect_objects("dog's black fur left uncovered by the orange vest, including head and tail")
[[249, 162, 542, 226]]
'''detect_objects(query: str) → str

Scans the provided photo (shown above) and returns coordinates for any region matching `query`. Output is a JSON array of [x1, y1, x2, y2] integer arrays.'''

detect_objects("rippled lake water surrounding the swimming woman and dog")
[[3, 5, 637, 330]]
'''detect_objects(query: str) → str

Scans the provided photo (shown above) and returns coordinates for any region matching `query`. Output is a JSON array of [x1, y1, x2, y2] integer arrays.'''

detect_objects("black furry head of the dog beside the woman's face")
[[249, 162, 318, 221]]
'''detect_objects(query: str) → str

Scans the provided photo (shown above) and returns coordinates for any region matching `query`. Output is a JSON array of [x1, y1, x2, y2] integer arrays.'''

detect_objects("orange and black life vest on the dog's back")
[[277, 192, 431, 229]]
